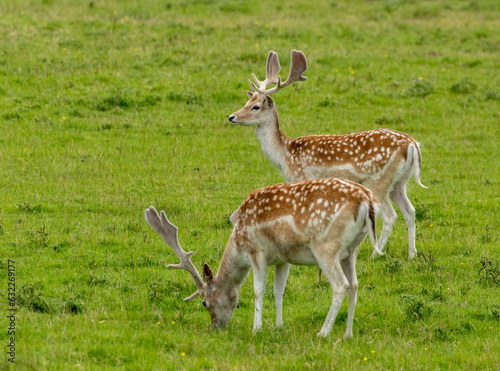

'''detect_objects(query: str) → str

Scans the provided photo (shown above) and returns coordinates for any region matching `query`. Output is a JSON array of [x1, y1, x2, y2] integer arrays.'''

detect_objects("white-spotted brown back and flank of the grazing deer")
[[231, 179, 376, 248]]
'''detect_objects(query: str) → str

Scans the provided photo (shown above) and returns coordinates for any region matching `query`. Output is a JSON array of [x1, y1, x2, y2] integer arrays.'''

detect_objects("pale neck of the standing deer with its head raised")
[[255, 108, 287, 171]]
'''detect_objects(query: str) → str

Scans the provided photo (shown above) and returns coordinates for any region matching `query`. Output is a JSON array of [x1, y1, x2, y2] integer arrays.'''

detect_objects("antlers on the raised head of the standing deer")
[[248, 49, 307, 95]]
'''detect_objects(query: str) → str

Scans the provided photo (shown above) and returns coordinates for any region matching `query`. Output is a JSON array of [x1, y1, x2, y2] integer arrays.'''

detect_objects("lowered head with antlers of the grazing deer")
[[146, 206, 238, 329]]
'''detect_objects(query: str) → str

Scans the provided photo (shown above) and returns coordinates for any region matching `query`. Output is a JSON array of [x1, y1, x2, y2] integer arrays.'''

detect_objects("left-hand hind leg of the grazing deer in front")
[[318, 256, 349, 337]]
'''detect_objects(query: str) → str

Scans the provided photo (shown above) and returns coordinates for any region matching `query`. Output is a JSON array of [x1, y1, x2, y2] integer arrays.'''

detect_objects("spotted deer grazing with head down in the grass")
[[146, 179, 377, 338]]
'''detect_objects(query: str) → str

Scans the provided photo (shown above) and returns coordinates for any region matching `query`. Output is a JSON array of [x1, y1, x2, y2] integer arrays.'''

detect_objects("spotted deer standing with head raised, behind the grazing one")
[[229, 50, 427, 258]]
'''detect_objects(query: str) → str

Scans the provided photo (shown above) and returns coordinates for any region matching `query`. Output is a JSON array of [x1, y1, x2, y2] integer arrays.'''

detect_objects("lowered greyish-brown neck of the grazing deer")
[[215, 235, 252, 290]]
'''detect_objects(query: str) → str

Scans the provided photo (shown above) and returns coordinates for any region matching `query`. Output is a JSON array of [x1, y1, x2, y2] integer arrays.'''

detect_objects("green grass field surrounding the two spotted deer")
[[0, 0, 500, 370]]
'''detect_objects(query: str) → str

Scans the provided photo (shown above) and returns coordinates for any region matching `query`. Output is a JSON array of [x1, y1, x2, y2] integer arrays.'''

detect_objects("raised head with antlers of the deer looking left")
[[229, 49, 307, 126]]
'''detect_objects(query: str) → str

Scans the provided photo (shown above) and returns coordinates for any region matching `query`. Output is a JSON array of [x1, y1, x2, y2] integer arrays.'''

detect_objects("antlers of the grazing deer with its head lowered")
[[146, 206, 205, 301]]
